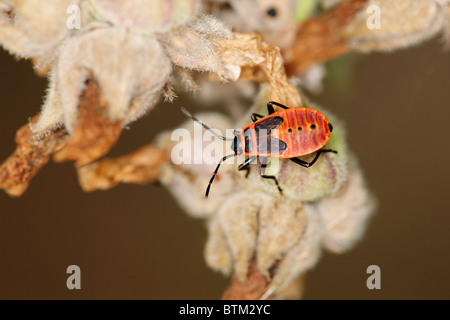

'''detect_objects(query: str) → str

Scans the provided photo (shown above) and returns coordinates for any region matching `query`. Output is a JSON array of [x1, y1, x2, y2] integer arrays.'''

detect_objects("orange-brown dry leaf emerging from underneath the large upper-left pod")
[[53, 83, 122, 167]]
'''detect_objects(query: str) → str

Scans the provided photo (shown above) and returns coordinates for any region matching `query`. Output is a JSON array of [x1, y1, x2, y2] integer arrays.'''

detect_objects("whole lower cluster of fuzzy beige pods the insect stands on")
[[154, 93, 374, 297]]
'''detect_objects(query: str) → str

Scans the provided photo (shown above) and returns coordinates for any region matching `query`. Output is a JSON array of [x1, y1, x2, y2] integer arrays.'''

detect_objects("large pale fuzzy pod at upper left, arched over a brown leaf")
[[32, 28, 171, 134]]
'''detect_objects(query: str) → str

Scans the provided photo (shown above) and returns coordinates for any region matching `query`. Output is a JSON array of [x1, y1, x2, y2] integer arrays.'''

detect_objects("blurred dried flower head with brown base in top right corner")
[[283, 0, 449, 75]]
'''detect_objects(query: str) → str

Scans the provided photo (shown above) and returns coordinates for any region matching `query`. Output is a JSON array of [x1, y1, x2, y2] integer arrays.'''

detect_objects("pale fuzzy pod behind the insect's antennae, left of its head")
[[156, 113, 235, 217]]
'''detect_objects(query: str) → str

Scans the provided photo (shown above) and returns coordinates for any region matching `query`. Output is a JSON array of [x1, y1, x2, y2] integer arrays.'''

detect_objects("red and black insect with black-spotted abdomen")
[[181, 101, 337, 197]]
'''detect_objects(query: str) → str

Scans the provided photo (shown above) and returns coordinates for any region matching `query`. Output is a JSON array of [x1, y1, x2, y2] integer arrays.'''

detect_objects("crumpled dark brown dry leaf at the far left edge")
[[0, 116, 68, 197]]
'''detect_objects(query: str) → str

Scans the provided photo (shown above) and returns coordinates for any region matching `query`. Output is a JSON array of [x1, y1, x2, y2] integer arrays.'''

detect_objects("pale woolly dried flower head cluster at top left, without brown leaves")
[[0, 0, 243, 136]]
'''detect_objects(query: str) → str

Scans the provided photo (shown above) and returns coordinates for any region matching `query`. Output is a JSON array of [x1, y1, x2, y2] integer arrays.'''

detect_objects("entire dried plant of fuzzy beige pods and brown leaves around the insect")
[[0, 0, 450, 299]]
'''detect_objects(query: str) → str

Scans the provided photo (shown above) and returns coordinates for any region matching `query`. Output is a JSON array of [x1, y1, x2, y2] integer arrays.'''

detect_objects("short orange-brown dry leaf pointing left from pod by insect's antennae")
[[78, 145, 170, 192]]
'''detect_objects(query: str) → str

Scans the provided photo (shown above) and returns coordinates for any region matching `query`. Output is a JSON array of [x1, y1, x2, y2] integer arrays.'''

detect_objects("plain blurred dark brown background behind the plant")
[[0, 40, 450, 299]]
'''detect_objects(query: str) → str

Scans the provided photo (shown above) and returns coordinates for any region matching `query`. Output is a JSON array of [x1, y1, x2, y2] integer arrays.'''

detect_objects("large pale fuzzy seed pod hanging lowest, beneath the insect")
[[205, 152, 374, 294]]
